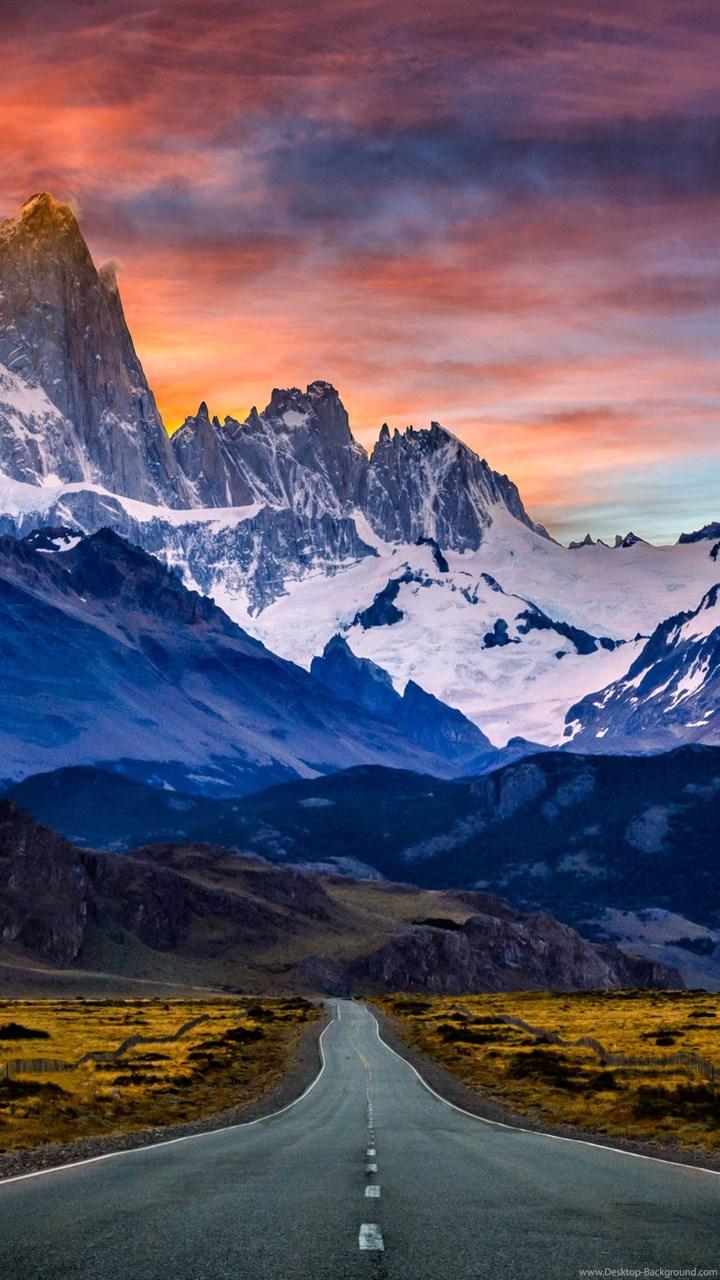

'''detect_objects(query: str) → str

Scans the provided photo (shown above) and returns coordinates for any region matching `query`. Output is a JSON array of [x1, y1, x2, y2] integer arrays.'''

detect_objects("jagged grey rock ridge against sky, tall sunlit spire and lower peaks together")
[[0, 192, 544, 549]]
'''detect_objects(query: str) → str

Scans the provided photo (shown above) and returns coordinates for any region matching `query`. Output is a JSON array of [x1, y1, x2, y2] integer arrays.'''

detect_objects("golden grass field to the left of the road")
[[0, 997, 319, 1152]]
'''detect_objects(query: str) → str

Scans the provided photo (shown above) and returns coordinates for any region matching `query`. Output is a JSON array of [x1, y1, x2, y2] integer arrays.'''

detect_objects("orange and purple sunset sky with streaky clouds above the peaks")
[[0, 0, 720, 540]]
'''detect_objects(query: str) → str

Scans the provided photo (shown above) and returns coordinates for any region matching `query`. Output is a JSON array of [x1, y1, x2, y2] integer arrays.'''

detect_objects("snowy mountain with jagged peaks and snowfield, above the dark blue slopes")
[[0, 188, 720, 748]]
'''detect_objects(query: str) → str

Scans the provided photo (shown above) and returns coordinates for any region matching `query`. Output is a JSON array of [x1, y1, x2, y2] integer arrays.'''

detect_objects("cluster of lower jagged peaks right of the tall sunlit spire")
[[172, 381, 547, 550]]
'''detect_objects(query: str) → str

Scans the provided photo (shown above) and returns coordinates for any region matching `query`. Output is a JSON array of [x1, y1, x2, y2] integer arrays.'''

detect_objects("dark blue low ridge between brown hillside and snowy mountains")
[[8, 746, 720, 989]]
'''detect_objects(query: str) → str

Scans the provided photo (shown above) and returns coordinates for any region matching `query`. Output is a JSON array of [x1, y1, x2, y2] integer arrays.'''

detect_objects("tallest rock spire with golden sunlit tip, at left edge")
[[0, 193, 187, 506]]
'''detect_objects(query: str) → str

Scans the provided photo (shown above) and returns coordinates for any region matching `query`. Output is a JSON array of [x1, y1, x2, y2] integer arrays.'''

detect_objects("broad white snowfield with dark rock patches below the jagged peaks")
[[239, 512, 717, 746]]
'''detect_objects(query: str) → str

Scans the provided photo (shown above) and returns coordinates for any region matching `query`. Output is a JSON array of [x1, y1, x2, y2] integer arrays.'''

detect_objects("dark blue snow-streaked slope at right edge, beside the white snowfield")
[[565, 585, 720, 751]]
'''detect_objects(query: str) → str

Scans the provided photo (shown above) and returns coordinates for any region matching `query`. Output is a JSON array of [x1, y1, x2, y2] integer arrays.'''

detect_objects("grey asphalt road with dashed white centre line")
[[0, 1001, 720, 1280]]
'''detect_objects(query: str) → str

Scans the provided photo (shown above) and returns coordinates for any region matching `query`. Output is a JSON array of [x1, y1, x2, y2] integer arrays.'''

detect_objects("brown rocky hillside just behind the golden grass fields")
[[0, 801, 679, 993]]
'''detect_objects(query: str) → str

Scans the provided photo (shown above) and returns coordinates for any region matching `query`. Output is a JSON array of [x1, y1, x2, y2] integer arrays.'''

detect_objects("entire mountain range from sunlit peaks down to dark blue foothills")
[[0, 193, 720, 989]]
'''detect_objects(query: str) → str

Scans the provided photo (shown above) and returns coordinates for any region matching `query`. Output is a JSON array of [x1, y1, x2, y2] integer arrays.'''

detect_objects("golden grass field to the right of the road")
[[377, 991, 720, 1152]]
